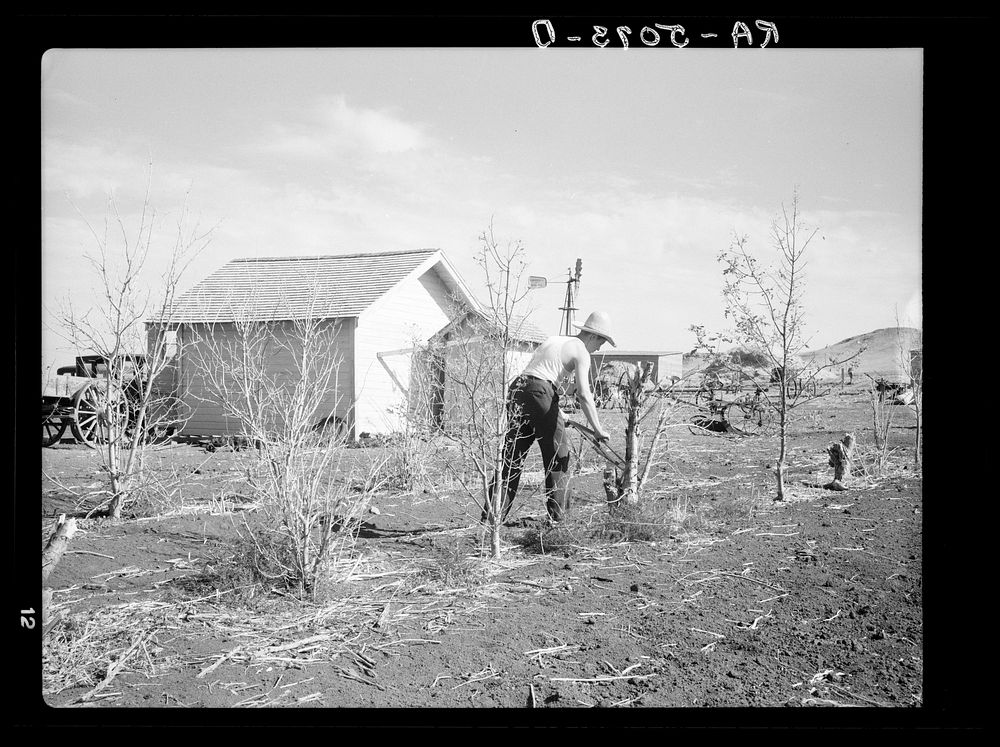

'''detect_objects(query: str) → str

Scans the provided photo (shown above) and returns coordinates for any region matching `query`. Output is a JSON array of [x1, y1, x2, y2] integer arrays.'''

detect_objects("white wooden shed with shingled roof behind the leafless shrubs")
[[158, 249, 476, 437]]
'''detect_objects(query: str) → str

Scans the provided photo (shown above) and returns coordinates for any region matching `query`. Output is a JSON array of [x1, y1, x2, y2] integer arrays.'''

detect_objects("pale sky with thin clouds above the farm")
[[41, 47, 923, 368]]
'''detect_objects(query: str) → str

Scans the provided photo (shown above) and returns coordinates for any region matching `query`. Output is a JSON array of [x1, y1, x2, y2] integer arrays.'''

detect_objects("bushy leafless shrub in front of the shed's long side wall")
[[192, 296, 385, 595]]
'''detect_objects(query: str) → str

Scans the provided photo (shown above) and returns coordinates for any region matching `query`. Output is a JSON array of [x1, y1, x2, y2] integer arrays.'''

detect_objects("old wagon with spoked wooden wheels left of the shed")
[[42, 353, 178, 447]]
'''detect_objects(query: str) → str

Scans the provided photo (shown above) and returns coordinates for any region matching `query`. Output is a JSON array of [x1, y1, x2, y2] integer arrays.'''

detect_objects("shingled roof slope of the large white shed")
[[171, 249, 438, 322]]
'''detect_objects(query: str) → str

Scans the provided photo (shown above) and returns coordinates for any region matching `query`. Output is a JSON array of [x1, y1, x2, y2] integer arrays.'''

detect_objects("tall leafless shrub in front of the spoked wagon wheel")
[[51, 171, 212, 519]]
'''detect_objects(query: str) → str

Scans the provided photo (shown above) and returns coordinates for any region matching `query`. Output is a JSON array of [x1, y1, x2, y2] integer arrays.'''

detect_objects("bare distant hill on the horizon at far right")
[[801, 327, 923, 383]]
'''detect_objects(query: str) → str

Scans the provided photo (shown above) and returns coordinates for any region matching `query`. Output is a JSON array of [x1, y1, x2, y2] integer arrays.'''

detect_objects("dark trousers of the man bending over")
[[483, 376, 570, 521]]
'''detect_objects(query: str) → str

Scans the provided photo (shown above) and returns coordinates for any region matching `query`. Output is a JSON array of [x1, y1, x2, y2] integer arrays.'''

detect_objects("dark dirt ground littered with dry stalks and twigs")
[[29, 388, 960, 725]]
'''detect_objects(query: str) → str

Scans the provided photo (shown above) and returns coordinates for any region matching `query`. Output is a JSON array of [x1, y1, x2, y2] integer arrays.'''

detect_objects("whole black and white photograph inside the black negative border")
[[16, 12, 988, 726]]
